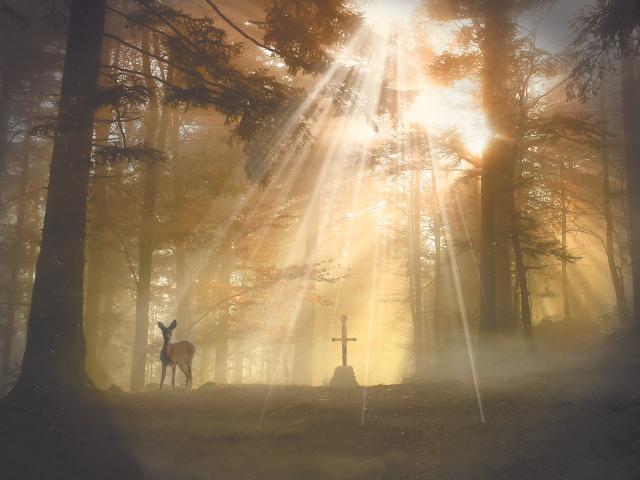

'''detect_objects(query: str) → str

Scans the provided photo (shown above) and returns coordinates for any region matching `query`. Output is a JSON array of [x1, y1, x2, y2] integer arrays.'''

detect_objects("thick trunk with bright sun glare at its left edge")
[[480, 0, 514, 336]]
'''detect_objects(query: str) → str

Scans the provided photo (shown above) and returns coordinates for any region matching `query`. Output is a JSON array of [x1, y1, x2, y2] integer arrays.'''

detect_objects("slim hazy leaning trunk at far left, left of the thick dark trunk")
[[2, 132, 31, 392]]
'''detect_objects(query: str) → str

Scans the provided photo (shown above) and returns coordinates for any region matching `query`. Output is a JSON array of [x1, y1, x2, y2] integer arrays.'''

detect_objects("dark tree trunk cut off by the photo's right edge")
[[622, 43, 640, 329]]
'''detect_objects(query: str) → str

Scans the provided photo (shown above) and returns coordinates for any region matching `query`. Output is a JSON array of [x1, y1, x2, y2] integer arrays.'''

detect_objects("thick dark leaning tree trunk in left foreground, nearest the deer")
[[14, 0, 105, 394]]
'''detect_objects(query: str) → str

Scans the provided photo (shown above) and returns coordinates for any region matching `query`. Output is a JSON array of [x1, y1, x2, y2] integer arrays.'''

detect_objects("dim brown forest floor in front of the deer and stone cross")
[[3, 332, 640, 480]]
